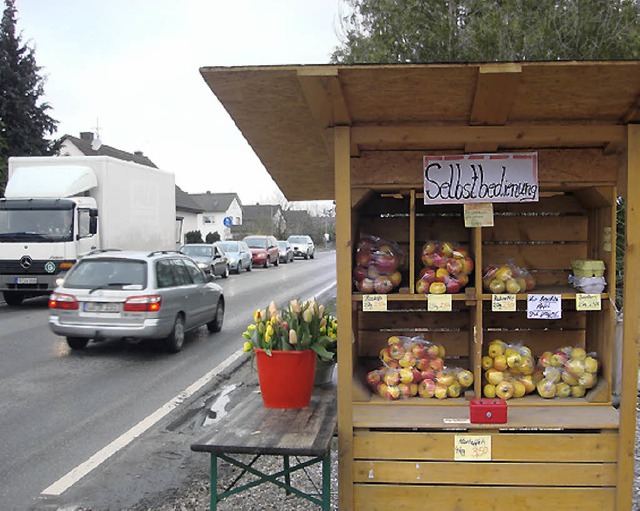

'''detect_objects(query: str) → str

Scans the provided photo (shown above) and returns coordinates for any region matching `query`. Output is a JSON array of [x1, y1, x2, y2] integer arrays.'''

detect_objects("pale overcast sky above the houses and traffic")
[[15, 0, 346, 204]]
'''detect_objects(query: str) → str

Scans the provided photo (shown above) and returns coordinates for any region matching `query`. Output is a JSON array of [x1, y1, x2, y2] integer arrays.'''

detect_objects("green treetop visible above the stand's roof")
[[331, 0, 640, 64]]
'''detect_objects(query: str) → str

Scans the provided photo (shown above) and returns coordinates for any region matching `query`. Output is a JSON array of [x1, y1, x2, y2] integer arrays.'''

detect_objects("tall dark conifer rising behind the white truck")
[[0, 0, 58, 196]]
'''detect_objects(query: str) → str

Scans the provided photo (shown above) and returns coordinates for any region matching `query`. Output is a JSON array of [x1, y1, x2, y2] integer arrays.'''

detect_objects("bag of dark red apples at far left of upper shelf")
[[353, 235, 404, 294]]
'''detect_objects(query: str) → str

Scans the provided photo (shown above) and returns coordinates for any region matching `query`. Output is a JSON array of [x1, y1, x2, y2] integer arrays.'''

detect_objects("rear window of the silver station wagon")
[[64, 259, 147, 289]]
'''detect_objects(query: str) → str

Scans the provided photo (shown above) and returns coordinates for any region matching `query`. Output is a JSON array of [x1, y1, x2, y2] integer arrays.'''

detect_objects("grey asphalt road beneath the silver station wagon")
[[0, 252, 335, 510]]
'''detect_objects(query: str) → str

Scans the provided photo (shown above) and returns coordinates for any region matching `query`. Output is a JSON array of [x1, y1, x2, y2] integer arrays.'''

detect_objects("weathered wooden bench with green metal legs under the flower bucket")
[[191, 385, 337, 511]]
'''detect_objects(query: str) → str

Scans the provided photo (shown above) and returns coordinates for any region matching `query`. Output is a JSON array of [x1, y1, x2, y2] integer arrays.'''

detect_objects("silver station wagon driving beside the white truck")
[[49, 250, 224, 353]]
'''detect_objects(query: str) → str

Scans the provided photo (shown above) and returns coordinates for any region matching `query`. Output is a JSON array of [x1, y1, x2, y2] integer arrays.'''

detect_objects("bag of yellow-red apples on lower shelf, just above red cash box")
[[481, 339, 536, 401]]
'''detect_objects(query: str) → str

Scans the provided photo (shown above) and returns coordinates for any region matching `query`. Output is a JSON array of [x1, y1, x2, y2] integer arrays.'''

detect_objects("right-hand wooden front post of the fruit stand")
[[617, 124, 640, 510]]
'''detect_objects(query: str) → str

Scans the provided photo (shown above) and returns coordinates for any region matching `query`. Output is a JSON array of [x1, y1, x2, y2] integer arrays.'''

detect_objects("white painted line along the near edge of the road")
[[42, 349, 245, 495]]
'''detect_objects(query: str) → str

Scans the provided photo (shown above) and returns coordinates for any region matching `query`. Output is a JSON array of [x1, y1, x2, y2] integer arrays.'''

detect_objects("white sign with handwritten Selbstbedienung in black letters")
[[423, 153, 538, 204]]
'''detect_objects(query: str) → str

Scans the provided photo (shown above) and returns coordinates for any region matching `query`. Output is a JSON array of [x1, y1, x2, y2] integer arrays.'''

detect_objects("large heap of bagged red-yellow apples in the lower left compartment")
[[367, 335, 473, 400]]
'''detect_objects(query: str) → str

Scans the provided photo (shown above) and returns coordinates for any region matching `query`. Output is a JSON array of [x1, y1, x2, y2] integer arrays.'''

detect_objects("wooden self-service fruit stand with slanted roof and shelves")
[[201, 61, 640, 511]]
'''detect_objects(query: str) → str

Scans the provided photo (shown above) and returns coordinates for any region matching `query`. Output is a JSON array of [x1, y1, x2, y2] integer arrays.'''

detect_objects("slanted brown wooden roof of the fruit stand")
[[200, 61, 640, 200]]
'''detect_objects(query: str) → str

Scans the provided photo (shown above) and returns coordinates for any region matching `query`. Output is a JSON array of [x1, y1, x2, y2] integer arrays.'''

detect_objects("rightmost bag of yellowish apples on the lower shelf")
[[533, 346, 599, 399]]
